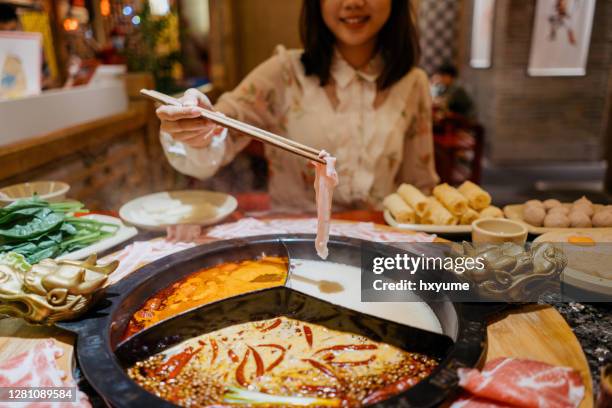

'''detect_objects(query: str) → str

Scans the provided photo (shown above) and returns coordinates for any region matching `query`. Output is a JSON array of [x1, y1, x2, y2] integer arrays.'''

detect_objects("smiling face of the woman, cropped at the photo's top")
[[321, 0, 391, 46]]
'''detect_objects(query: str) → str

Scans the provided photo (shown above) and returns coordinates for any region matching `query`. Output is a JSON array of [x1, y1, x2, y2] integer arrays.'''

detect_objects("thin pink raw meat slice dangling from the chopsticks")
[[312, 150, 338, 259]]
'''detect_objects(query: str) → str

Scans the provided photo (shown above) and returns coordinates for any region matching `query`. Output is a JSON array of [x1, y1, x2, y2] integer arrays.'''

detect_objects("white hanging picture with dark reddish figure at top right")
[[527, 0, 595, 76]]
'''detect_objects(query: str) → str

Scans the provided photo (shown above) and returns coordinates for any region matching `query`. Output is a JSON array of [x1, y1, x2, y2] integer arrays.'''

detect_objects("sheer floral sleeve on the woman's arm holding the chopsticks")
[[160, 49, 287, 179]]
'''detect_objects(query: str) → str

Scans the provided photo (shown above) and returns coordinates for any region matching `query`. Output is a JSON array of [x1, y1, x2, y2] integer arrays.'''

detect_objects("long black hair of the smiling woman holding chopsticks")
[[300, 0, 420, 89]]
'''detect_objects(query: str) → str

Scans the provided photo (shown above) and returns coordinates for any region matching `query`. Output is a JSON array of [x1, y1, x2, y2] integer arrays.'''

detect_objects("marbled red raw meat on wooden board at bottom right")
[[457, 357, 584, 408]]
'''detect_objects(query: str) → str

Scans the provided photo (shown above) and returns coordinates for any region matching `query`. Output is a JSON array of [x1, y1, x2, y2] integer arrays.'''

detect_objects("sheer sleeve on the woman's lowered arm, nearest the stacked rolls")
[[398, 70, 440, 194]]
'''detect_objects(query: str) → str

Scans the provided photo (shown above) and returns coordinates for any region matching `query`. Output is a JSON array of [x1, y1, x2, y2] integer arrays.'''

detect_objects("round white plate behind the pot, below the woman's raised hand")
[[119, 190, 238, 231]]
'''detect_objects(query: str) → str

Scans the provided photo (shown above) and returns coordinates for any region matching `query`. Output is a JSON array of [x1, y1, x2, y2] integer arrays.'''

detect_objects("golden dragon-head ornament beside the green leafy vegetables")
[[0, 255, 119, 324]]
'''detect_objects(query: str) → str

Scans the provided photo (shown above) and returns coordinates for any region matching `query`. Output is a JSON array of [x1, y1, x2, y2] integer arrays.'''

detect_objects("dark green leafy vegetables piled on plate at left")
[[0, 196, 119, 264]]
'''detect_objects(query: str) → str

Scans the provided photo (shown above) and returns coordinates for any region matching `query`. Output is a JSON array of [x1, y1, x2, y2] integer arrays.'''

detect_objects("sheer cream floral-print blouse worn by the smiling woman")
[[161, 46, 438, 211]]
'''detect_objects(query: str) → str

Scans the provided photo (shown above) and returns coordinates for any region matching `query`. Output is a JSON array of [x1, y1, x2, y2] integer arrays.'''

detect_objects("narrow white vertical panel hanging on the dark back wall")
[[470, 0, 495, 68]]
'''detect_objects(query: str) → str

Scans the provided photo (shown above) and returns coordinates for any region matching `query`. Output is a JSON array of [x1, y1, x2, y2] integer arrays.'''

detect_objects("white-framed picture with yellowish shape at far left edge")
[[0, 31, 42, 99]]
